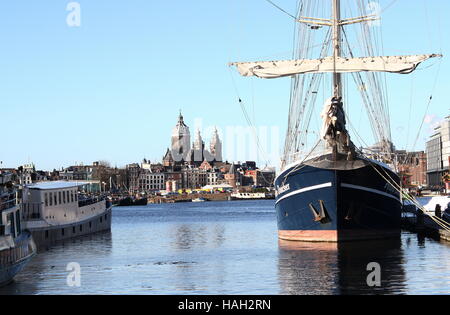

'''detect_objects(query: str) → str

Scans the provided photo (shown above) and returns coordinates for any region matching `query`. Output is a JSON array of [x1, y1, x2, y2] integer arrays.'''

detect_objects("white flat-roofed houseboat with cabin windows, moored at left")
[[22, 181, 112, 247]]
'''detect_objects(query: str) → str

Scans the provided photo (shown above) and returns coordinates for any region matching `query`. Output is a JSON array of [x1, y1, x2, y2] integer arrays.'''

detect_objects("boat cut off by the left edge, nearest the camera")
[[0, 174, 36, 286]]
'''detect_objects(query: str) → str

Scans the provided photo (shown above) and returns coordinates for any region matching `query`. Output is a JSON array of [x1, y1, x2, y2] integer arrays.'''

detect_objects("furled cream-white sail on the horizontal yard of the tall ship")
[[230, 54, 441, 79]]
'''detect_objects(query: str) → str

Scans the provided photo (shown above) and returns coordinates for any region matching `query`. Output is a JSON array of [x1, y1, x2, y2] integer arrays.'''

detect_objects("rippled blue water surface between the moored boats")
[[0, 200, 450, 295]]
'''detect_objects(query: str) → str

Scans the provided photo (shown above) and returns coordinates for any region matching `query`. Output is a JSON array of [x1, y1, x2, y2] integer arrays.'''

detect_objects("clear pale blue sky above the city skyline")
[[0, 0, 450, 169]]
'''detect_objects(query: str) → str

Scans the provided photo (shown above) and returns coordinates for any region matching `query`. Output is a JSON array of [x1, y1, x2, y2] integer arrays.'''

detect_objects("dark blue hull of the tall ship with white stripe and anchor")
[[275, 159, 401, 242]]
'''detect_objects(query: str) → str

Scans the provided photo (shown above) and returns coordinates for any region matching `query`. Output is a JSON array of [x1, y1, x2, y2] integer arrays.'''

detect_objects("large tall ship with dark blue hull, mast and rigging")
[[230, 0, 441, 242]]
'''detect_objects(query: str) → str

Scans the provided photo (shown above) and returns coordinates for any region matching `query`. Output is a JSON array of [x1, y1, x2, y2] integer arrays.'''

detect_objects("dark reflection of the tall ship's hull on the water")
[[279, 238, 406, 294]]
